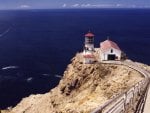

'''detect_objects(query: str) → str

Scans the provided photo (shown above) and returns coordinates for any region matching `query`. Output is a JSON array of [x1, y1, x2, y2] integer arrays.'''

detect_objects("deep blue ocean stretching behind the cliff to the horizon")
[[0, 9, 150, 108]]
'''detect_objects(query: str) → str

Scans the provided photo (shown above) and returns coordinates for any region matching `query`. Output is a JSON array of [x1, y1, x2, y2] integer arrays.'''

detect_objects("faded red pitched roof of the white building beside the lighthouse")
[[100, 39, 120, 52]]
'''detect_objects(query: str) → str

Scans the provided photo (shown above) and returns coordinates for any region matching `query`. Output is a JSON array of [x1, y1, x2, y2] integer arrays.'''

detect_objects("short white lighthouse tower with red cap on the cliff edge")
[[83, 32, 95, 64]]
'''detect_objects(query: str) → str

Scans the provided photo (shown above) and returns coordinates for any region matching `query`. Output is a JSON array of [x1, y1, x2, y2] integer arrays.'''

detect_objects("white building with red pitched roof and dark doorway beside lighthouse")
[[100, 39, 122, 61]]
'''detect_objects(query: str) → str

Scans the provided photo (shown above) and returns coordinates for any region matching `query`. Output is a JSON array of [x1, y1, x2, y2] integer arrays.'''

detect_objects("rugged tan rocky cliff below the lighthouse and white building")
[[2, 54, 146, 113]]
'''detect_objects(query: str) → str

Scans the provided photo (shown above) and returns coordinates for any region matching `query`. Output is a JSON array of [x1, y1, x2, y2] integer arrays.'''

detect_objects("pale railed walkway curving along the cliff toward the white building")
[[91, 61, 150, 113]]
